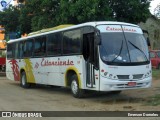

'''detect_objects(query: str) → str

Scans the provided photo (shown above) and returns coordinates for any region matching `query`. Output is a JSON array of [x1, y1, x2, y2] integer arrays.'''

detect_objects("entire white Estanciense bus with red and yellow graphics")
[[6, 21, 152, 98]]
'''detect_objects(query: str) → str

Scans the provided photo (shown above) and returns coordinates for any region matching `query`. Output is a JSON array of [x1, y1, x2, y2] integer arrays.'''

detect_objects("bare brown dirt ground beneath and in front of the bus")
[[0, 77, 160, 111]]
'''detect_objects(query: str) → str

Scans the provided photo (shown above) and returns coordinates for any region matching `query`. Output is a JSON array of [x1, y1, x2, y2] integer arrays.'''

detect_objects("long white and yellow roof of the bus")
[[8, 21, 139, 43]]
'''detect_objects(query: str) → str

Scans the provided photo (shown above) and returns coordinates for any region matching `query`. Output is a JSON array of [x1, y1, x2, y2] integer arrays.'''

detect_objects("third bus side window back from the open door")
[[34, 36, 46, 56]]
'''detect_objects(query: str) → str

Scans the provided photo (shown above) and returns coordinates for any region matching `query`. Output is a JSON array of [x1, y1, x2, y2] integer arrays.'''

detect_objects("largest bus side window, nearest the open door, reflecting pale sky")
[[63, 29, 82, 54]]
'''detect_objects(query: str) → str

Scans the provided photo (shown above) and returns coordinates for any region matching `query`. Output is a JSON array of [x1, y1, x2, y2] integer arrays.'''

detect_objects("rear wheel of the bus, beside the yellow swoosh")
[[20, 72, 31, 88]]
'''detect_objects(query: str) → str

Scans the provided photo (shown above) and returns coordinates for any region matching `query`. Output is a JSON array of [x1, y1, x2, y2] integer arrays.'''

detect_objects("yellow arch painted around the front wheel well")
[[65, 66, 82, 88]]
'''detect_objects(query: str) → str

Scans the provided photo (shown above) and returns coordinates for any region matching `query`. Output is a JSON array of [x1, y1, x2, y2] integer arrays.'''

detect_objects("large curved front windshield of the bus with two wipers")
[[100, 27, 149, 64]]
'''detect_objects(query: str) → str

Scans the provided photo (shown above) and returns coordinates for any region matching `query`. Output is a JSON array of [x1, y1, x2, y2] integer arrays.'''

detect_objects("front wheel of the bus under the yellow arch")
[[71, 75, 84, 98]]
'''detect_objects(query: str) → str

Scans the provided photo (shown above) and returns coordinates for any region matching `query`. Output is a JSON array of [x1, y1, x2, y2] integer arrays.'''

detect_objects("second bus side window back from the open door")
[[47, 33, 62, 55]]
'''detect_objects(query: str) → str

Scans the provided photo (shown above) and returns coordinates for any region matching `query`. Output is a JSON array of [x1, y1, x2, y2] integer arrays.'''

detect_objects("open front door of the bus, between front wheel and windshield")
[[83, 27, 99, 89]]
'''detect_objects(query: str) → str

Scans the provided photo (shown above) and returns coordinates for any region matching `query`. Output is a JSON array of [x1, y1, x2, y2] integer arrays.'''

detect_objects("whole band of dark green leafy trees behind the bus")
[[0, 0, 150, 33]]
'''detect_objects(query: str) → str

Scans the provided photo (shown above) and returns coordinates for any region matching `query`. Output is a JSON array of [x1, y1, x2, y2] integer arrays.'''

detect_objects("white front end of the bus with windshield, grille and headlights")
[[97, 24, 152, 92]]
